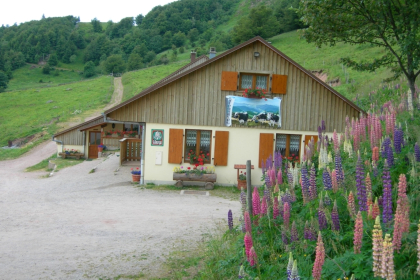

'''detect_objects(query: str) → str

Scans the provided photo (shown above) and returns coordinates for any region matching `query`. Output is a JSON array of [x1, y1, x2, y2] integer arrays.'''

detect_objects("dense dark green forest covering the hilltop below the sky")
[[0, 0, 301, 79]]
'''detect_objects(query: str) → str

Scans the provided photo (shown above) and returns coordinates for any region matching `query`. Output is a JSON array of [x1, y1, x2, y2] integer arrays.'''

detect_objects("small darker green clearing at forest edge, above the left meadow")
[[7, 65, 84, 91]]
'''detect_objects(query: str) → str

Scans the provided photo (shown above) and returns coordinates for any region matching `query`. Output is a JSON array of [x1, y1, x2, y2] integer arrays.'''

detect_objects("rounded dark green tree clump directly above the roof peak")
[[232, 5, 280, 44]]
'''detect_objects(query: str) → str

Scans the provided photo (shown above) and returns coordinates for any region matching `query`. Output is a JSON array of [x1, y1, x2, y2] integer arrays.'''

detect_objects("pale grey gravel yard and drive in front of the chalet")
[[0, 142, 240, 279]]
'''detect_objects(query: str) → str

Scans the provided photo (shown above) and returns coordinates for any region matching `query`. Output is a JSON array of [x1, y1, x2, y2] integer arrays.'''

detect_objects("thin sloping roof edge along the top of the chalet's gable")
[[105, 36, 366, 114]]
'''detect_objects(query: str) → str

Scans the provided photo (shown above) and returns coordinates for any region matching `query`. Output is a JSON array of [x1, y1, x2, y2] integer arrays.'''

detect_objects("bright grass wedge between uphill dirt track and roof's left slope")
[[122, 61, 190, 101]]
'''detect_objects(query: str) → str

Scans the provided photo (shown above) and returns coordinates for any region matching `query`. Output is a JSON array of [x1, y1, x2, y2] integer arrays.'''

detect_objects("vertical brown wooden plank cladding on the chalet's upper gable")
[[105, 39, 363, 132]]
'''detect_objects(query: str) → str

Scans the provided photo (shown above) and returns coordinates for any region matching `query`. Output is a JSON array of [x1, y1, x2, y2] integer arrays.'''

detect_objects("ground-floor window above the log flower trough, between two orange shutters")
[[184, 129, 211, 163]]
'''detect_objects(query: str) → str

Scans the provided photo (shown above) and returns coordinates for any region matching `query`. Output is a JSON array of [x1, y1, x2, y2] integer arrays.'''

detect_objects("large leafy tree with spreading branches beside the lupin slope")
[[299, 0, 420, 101]]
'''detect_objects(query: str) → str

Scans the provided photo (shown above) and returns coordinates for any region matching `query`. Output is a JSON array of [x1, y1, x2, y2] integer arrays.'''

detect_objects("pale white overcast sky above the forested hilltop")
[[0, 0, 174, 26]]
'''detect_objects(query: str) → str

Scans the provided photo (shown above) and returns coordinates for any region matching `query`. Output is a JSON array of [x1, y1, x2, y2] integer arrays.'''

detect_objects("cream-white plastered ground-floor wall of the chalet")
[[143, 123, 318, 185]]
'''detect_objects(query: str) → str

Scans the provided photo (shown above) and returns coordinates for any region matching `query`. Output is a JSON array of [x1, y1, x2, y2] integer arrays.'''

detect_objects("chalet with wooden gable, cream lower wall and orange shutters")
[[53, 37, 364, 185]]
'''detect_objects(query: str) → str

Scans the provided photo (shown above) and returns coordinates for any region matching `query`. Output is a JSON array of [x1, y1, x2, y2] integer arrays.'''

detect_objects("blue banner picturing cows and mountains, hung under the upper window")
[[225, 95, 281, 128]]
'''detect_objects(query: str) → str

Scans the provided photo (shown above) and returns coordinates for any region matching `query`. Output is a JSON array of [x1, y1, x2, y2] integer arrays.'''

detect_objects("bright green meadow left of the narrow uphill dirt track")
[[0, 76, 114, 156]]
